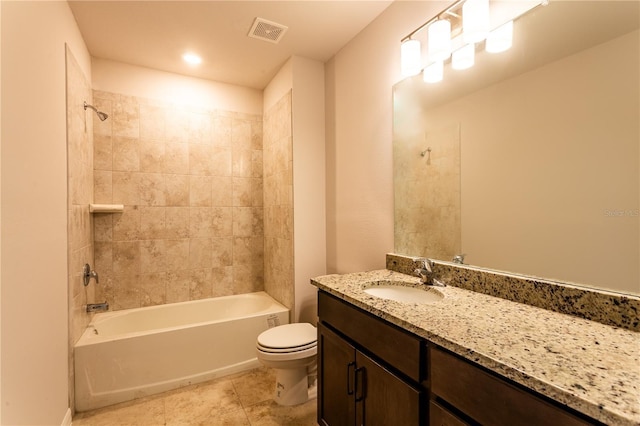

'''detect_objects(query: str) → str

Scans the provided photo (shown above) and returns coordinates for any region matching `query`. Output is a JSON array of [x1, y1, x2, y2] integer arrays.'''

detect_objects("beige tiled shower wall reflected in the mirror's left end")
[[393, 105, 461, 260]]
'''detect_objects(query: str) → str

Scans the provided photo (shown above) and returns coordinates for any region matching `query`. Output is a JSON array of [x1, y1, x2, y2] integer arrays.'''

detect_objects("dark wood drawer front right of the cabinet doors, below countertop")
[[429, 346, 593, 426]]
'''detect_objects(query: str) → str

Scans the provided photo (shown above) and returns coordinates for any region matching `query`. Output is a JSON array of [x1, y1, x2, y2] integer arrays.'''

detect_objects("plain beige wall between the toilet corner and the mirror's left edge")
[[325, 1, 444, 273]]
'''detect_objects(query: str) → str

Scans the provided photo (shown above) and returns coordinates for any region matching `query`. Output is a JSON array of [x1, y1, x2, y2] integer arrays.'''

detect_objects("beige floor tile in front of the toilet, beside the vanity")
[[245, 399, 318, 426]]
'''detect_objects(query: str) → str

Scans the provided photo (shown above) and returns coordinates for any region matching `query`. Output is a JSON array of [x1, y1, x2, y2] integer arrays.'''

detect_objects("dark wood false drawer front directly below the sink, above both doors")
[[318, 291, 426, 382]]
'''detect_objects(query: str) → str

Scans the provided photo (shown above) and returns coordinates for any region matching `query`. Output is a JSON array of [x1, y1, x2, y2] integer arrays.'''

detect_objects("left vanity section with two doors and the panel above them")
[[318, 292, 427, 426]]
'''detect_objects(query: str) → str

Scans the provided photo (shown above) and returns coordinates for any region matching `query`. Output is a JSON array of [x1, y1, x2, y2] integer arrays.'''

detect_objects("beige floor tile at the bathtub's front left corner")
[[73, 398, 165, 426]]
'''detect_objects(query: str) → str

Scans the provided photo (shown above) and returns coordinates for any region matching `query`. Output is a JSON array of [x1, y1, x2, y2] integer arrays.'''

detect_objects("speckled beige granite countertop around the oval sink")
[[311, 269, 640, 425]]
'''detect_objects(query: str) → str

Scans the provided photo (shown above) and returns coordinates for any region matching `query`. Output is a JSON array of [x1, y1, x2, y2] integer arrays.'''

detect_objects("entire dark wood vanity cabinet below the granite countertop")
[[318, 291, 601, 426]]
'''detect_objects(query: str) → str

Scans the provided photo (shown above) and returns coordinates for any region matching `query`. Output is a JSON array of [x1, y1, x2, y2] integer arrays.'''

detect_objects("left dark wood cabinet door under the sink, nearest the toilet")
[[318, 323, 356, 426]]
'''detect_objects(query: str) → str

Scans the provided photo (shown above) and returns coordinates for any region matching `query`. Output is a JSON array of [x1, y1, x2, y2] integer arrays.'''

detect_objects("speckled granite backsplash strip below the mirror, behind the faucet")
[[387, 254, 640, 331]]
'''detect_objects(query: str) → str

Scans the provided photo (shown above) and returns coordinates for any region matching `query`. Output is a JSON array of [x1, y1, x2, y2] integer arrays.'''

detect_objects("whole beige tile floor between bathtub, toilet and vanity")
[[73, 368, 317, 426]]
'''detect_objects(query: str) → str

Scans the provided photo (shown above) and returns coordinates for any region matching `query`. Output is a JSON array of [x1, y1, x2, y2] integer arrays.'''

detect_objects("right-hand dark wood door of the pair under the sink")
[[354, 352, 422, 426]]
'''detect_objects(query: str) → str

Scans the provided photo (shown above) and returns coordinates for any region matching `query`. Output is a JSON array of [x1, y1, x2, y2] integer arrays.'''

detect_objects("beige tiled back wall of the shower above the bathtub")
[[93, 91, 264, 310]]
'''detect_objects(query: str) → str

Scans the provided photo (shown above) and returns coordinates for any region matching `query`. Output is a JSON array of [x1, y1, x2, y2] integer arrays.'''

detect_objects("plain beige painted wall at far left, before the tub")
[[0, 1, 91, 425]]
